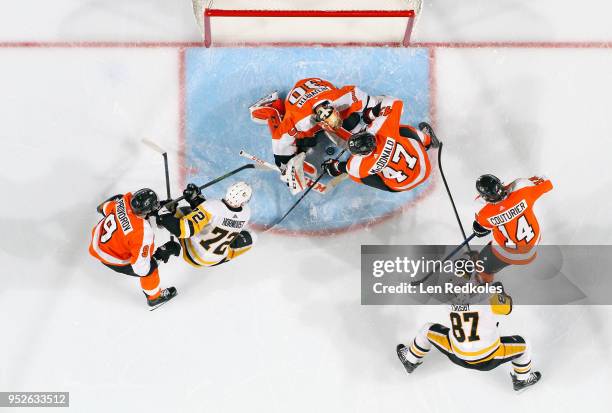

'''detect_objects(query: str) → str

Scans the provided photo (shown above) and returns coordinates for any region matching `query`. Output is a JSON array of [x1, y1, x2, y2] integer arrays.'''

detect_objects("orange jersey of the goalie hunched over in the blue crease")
[[272, 78, 368, 155]]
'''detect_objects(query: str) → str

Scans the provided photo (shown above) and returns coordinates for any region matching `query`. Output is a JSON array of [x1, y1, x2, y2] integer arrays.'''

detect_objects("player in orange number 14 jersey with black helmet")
[[473, 175, 553, 283]]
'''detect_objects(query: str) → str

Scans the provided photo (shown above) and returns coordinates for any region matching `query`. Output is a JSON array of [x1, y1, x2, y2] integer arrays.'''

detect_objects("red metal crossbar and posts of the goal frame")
[[204, 8, 416, 47]]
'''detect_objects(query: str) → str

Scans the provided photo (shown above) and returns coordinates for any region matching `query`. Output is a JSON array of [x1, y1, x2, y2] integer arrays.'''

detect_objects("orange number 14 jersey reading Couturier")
[[476, 176, 553, 264]]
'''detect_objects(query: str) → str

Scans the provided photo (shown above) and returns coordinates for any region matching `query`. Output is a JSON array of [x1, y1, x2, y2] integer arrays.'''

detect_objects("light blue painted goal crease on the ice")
[[185, 47, 430, 232]]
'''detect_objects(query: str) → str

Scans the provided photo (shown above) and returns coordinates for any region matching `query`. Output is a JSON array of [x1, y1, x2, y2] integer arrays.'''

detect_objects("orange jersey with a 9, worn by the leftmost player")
[[89, 193, 154, 276]]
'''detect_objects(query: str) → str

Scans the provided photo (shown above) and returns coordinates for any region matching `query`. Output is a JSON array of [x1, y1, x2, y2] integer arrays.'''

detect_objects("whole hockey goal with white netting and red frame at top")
[[192, 0, 422, 47]]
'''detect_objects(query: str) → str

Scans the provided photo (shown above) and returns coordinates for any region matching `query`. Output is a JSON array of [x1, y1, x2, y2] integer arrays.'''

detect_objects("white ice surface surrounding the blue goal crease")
[[0, 0, 612, 412]]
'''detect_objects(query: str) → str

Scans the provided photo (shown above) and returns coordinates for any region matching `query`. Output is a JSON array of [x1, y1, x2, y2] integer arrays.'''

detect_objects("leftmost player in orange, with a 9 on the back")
[[89, 188, 181, 307]]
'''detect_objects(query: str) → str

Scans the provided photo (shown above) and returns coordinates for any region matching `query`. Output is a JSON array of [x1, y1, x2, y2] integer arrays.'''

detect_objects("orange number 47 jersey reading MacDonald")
[[346, 102, 431, 191]]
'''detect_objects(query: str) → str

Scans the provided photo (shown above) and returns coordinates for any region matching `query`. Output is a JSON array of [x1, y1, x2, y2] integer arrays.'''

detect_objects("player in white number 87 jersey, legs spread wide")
[[396, 283, 542, 391]]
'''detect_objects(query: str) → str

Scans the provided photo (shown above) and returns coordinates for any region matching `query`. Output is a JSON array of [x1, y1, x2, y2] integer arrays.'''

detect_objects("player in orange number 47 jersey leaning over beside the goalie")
[[322, 96, 440, 192]]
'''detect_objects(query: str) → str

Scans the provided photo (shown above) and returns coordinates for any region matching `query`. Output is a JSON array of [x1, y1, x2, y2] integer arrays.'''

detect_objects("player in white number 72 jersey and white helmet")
[[157, 182, 255, 268]]
